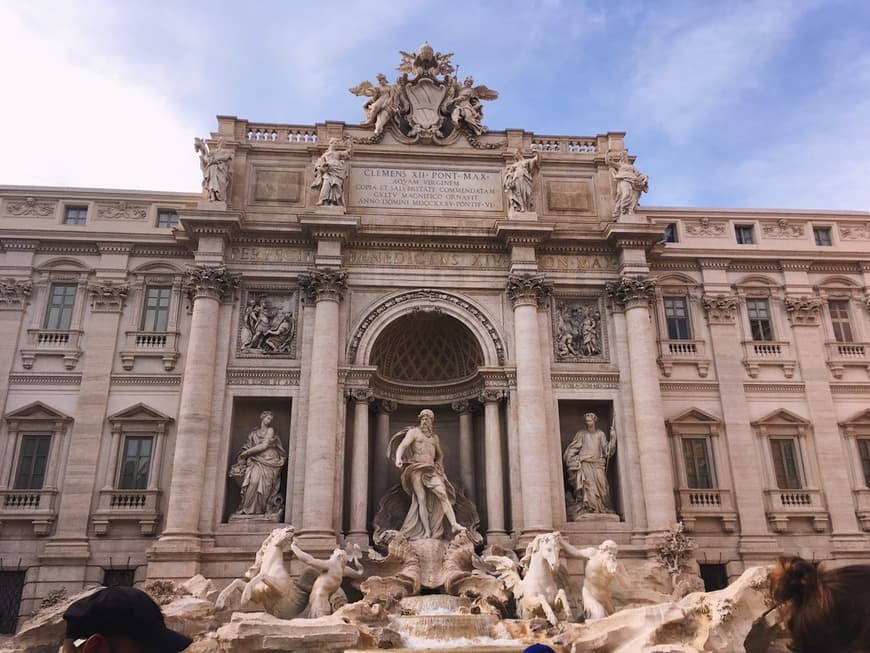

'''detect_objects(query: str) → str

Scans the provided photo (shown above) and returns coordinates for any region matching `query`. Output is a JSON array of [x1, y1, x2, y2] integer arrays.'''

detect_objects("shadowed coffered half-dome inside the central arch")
[[369, 311, 484, 394]]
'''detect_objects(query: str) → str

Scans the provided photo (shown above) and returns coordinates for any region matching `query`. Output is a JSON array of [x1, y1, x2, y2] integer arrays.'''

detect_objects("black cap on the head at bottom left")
[[63, 587, 193, 653]]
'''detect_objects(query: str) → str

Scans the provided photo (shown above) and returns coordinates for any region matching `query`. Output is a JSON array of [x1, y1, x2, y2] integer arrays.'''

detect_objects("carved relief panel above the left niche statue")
[[236, 289, 299, 358]]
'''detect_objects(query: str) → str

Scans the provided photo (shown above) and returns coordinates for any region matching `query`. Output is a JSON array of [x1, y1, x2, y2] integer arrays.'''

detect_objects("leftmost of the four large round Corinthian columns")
[[159, 265, 241, 540]]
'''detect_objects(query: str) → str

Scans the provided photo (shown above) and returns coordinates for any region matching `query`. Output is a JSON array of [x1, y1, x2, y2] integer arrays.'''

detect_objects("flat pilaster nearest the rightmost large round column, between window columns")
[[702, 292, 773, 557]]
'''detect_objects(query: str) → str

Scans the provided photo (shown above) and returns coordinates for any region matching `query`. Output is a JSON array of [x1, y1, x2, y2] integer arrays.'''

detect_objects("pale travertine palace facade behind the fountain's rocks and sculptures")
[[0, 45, 870, 632]]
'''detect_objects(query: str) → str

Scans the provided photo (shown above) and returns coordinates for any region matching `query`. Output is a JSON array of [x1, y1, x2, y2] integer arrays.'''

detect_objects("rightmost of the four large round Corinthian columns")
[[606, 277, 677, 532]]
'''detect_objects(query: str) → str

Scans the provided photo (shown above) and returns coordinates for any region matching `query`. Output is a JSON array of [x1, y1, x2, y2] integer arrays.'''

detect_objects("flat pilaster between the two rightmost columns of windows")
[[785, 296, 866, 536]]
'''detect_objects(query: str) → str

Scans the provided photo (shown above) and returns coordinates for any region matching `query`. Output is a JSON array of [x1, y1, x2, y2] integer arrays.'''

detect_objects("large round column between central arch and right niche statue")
[[507, 274, 555, 536]]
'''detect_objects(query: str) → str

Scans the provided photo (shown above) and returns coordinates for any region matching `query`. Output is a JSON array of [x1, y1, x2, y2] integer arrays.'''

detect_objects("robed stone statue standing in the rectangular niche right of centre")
[[563, 413, 616, 515]]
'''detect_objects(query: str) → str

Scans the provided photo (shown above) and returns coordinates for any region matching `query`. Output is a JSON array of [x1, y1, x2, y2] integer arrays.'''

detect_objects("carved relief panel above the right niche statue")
[[552, 297, 607, 363]]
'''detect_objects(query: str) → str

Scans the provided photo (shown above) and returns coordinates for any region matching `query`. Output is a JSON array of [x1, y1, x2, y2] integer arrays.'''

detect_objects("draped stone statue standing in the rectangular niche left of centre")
[[230, 410, 287, 521]]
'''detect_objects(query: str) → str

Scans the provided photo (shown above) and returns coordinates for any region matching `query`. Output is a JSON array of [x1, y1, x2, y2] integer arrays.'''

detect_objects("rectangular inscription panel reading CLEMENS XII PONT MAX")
[[350, 166, 504, 211]]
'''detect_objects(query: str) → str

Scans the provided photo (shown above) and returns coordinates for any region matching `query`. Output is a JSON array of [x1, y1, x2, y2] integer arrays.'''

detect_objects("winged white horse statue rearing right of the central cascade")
[[484, 532, 573, 626]]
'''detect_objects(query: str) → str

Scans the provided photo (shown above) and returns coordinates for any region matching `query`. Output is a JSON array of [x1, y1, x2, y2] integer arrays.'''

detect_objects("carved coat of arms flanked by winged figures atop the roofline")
[[350, 43, 501, 148]]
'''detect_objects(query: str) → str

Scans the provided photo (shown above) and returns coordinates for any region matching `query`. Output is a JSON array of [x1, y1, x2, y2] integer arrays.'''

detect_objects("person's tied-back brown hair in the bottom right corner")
[[769, 556, 870, 653]]
